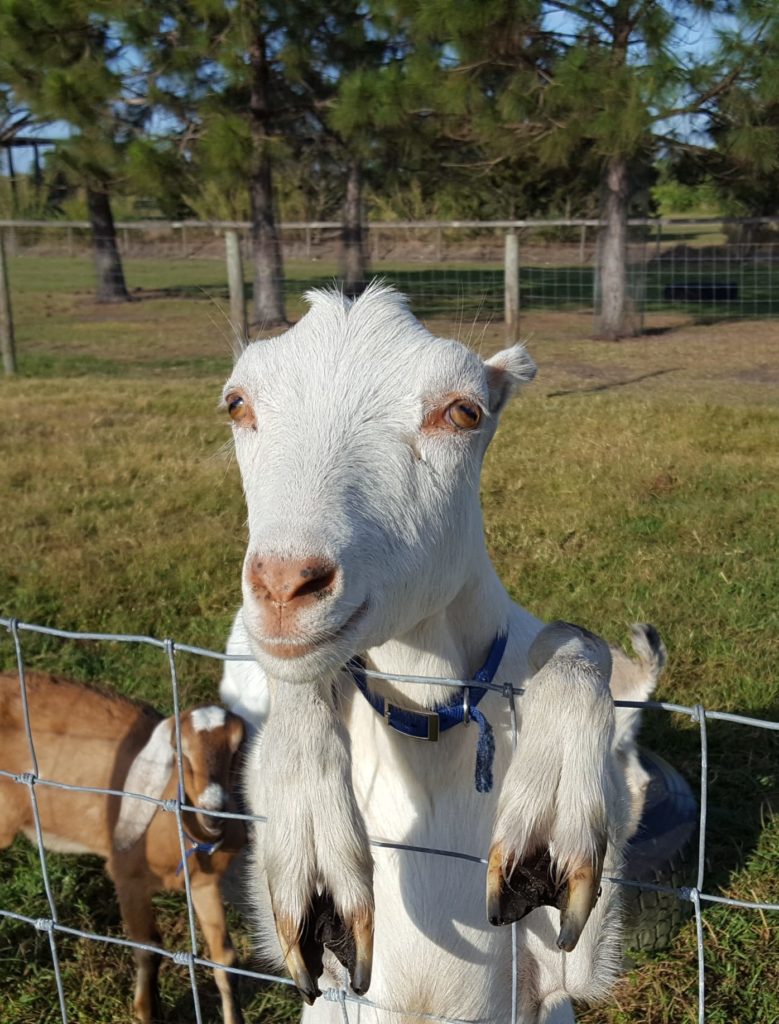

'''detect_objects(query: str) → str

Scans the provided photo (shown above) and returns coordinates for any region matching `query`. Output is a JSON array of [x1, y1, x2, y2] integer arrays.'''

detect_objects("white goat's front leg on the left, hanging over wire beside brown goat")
[[247, 681, 374, 1005]]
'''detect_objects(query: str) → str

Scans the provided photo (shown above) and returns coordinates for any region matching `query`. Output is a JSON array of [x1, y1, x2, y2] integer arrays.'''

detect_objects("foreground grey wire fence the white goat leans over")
[[0, 617, 779, 1024]]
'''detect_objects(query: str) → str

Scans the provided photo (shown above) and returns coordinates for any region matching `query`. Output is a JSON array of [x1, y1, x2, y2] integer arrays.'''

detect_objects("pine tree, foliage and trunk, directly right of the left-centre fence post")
[[135, 0, 350, 326]]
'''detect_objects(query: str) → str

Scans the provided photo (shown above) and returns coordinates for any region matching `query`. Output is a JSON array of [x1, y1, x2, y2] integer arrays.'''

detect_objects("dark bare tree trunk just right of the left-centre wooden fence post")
[[249, 33, 287, 327]]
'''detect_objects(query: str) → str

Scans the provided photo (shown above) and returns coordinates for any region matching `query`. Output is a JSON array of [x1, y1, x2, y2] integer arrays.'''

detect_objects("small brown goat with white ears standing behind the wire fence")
[[0, 672, 246, 1024]]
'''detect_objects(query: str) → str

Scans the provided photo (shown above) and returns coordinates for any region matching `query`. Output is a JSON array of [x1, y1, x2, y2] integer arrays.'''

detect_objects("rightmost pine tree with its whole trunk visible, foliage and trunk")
[[406, 0, 739, 339]]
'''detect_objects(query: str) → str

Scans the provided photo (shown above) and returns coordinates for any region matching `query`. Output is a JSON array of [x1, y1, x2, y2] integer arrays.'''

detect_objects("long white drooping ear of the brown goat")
[[114, 718, 174, 850]]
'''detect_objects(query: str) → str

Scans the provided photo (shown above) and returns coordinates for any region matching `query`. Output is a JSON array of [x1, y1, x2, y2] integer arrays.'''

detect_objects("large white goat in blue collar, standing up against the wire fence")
[[217, 287, 663, 1024]]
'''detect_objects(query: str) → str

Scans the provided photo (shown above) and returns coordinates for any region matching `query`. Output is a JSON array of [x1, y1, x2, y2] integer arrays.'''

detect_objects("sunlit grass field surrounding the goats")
[[0, 260, 779, 1024]]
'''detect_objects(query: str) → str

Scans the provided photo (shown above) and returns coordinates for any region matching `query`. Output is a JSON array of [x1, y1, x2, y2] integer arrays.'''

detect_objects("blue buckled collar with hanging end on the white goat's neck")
[[347, 633, 508, 793]]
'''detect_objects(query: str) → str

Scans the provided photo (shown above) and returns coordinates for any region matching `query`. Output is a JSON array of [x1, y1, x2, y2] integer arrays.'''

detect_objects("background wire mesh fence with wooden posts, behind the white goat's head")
[[0, 218, 779, 329]]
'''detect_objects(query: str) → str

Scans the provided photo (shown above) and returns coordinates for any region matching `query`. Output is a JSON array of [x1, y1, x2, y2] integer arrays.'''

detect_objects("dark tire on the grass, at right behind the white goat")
[[622, 751, 698, 952]]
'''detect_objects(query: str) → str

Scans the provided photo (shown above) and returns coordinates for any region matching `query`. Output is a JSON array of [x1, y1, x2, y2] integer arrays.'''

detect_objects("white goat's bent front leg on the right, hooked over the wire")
[[487, 622, 617, 952]]
